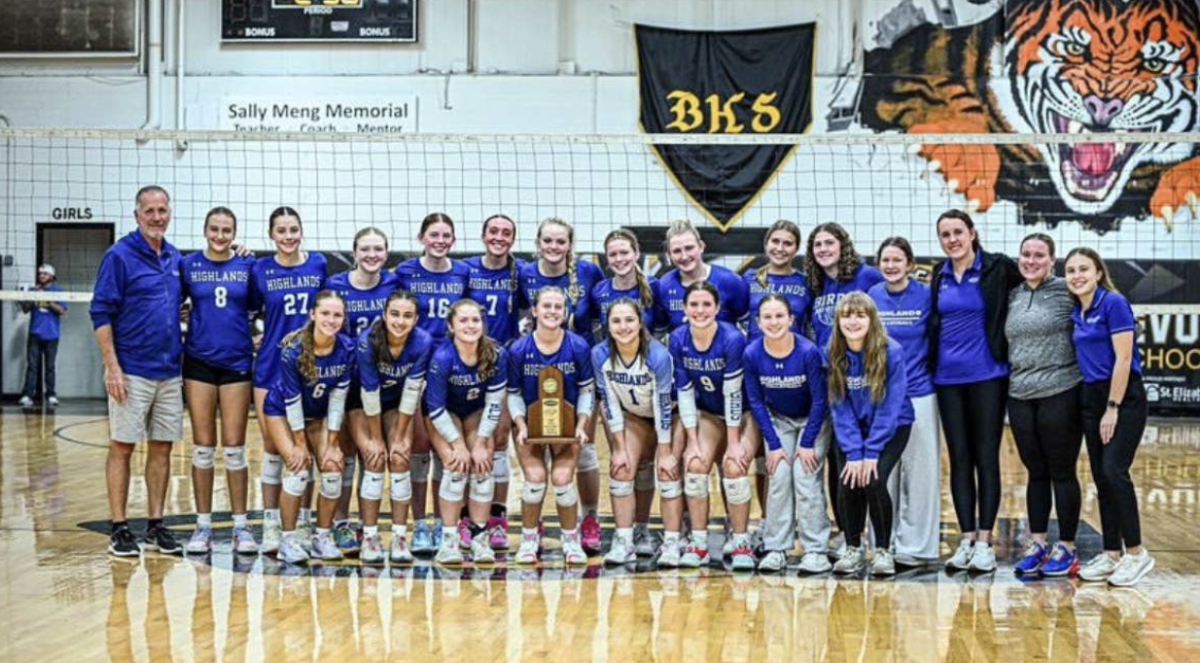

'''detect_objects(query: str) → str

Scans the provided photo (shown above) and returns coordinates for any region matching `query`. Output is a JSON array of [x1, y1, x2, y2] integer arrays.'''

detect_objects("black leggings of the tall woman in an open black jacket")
[[937, 377, 1008, 534]]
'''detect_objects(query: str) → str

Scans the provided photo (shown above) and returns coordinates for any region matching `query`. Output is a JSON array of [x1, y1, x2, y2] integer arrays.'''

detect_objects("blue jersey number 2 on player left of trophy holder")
[[425, 341, 509, 419]]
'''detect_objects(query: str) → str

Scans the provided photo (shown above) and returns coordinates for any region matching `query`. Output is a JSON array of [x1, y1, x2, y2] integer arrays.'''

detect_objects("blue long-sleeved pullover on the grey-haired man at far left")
[[89, 229, 184, 380]]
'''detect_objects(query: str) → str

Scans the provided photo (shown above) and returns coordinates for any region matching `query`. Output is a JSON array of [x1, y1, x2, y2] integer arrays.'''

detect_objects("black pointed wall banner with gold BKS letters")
[[635, 23, 816, 232]]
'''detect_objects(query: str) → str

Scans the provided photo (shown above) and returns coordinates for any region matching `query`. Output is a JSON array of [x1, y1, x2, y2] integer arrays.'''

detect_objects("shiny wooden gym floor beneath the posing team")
[[0, 404, 1200, 663]]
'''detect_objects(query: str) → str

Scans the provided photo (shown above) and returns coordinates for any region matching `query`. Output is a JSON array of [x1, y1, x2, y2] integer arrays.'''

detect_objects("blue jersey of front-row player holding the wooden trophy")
[[509, 332, 595, 416]]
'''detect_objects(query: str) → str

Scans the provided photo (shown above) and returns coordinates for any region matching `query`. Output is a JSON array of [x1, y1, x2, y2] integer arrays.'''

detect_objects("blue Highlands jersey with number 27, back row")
[[251, 251, 325, 388]]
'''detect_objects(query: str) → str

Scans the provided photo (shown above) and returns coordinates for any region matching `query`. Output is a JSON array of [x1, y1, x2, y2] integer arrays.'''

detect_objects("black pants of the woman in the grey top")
[[1008, 384, 1084, 540]]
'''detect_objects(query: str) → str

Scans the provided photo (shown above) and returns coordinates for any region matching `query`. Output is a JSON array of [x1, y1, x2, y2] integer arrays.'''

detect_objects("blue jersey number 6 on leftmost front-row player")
[[263, 334, 356, 430]]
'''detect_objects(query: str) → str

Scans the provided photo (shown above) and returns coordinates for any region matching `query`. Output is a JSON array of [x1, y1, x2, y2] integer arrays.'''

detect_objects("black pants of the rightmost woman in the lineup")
[[1084, 374, 1148, 553]]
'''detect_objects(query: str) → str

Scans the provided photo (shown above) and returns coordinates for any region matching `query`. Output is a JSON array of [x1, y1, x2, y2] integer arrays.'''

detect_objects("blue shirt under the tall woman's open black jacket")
[[934, 251, 1008, 387]]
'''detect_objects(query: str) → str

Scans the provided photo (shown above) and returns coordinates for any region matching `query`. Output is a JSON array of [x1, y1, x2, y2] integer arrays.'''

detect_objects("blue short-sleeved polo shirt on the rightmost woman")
[[1070, 287, 1141, 383]]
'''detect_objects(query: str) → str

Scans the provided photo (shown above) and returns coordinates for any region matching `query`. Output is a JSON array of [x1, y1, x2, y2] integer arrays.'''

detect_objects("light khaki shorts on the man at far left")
[[108, 375, 184, 444]]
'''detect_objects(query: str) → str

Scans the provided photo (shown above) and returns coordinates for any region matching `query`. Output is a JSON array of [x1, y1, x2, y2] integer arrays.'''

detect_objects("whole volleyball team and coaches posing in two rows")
[[88, 185, 1154, 586]]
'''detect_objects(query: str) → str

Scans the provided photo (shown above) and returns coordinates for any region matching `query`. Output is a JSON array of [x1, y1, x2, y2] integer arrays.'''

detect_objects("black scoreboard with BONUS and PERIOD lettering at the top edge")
[[221, 0, 419, 42]]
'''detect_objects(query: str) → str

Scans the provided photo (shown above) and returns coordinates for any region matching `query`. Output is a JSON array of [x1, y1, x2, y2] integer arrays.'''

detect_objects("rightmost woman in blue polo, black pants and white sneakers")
[[1067, 246, 1154, 586]]
